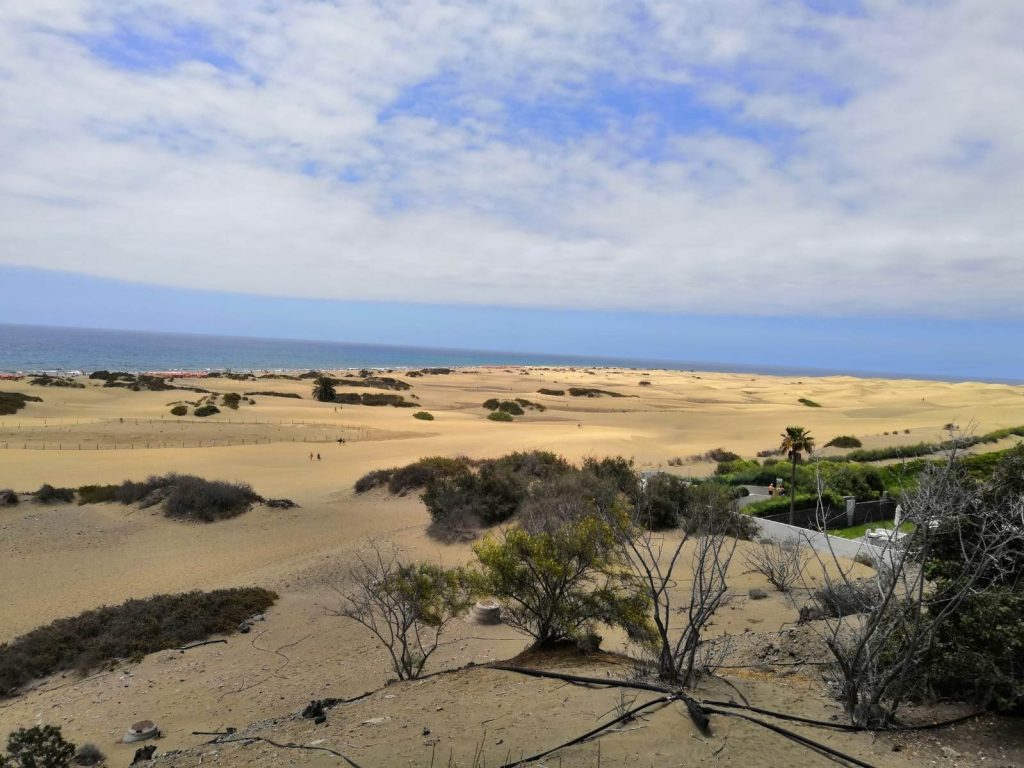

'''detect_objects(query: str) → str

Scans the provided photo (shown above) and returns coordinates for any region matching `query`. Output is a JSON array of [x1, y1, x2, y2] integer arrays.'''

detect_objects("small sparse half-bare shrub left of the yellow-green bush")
[[335, 542, 473, 680]]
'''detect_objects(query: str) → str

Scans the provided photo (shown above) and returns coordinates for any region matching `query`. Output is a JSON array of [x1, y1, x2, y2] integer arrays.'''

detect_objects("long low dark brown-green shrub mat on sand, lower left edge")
[[0, 587, 278, 695]]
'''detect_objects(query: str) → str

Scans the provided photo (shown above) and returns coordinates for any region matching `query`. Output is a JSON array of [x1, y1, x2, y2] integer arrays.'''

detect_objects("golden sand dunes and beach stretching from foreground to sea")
[[0, 368, 1024, 768]]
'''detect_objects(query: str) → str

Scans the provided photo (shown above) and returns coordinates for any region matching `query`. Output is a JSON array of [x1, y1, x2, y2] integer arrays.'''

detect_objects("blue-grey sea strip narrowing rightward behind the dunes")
[[0, 324, 991, 378]]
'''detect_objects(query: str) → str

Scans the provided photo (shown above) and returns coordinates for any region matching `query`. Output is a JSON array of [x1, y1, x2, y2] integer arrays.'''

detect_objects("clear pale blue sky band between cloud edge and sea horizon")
[[6, 267, 1024, 381]]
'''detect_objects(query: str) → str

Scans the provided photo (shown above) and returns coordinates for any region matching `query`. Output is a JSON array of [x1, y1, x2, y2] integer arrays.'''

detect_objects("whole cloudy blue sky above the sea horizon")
[[0, 0, 1024, 378]]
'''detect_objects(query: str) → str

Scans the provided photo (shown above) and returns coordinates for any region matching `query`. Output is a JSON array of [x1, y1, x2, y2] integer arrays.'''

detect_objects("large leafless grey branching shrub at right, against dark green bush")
[[798, 452, 1024, 727]]
